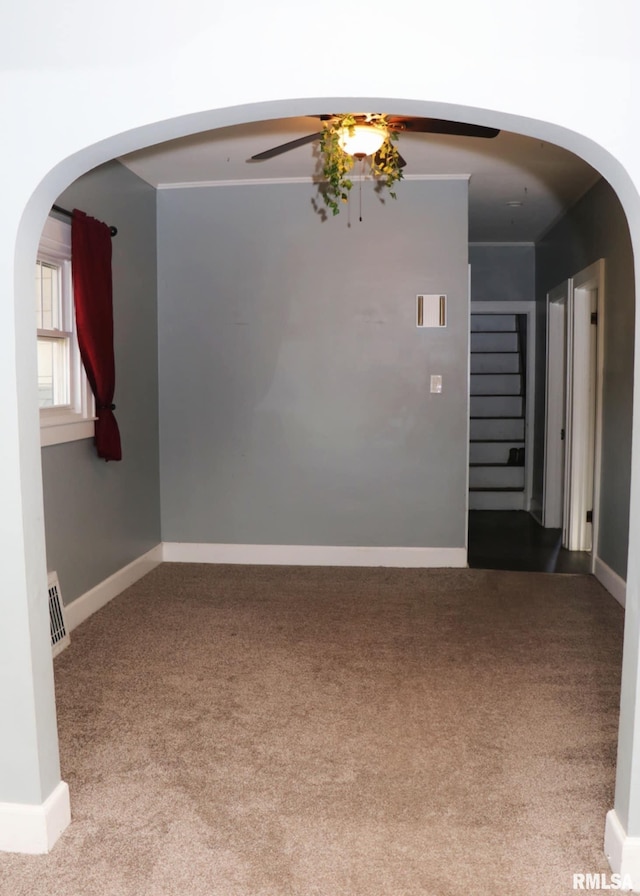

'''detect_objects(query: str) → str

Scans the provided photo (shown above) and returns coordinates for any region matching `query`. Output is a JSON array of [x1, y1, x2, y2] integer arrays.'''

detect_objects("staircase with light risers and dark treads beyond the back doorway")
[[469, 313, 526, 510]]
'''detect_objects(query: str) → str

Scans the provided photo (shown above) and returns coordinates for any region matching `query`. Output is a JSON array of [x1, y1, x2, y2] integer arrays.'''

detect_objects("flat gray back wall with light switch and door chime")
[[158, 181, 468, 547]]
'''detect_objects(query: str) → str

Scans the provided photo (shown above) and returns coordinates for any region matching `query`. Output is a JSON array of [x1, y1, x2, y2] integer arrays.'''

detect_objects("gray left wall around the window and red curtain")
[[42, 162, 160, 603]]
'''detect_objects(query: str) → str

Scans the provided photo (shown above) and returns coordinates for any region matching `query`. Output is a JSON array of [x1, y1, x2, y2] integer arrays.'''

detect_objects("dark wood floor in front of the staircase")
[[469, 510, 591, 573]]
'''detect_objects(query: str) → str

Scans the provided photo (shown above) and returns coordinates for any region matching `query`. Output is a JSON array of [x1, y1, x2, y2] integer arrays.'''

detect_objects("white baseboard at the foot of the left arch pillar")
[[0, 781, 71, 855]]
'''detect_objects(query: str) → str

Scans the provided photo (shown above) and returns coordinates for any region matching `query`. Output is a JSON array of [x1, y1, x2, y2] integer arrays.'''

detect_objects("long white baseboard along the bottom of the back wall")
[[162, 541, 467, 568]]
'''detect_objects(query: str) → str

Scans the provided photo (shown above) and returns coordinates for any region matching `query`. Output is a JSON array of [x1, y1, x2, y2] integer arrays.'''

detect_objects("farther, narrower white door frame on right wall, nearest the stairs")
[[542, 280, 571, 529]]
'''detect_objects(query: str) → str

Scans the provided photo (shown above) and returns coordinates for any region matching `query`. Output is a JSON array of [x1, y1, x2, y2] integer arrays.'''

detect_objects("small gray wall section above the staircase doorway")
[[469, 243, 536, 302]]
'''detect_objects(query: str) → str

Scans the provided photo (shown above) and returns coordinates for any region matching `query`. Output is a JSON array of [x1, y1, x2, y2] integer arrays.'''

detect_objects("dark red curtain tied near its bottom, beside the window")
[[71, 209, 122, 460]]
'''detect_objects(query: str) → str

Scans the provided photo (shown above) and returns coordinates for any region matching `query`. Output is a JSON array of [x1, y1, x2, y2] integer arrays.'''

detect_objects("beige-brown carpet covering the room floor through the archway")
[[0, 564, 623, 896]]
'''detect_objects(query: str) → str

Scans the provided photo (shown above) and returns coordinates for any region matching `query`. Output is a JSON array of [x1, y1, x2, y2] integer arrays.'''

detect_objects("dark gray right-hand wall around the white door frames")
[[535, 180, 635, 578]]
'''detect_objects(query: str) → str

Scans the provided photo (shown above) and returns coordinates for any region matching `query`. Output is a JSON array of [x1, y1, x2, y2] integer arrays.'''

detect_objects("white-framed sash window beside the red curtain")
[[35, 218, 94, 446]]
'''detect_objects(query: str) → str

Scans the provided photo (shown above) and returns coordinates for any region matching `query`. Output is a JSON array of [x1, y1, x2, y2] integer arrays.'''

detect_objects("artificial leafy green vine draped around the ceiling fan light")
[[320, 114, 404, 215]]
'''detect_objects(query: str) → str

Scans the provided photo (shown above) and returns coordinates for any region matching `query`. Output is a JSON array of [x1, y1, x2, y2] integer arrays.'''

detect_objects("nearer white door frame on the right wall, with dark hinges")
[[565, 258, 605, 572]]
